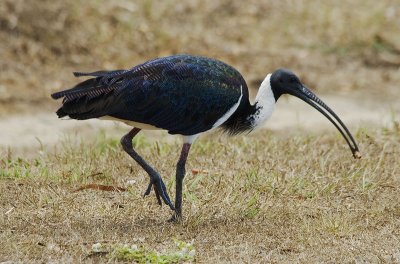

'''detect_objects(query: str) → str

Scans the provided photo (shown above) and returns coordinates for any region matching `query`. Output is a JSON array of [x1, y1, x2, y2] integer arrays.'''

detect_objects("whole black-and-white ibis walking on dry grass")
[[51, 54, 361, 221]]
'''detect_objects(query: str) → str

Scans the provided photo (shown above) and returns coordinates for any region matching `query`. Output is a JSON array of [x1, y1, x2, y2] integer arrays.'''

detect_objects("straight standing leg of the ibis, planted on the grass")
[[171, 143, 191, 221]]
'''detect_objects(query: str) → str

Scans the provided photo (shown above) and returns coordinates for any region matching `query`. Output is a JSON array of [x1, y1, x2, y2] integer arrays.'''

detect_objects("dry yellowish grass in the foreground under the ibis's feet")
[[0, 127, 400, 263]]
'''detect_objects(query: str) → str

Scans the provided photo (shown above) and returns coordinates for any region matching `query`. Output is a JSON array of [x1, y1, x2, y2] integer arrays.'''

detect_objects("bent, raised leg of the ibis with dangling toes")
[[121, 128, 175, 210]]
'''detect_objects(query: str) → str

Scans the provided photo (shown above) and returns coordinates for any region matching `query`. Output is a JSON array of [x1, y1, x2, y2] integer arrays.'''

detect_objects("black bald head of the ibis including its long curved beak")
[[270, 69, 361, 158]]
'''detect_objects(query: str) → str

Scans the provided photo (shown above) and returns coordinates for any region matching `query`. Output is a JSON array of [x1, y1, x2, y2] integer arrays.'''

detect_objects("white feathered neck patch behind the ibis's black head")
[[249, 74, 275, 128]]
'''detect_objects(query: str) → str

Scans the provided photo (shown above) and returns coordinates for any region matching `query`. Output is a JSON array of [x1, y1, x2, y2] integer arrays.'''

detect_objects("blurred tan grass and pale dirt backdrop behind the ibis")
[[0, 0, 400, 153]]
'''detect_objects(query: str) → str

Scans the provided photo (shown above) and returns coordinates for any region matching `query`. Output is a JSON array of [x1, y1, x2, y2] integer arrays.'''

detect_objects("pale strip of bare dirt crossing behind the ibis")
[[0, 95, 400, 157]]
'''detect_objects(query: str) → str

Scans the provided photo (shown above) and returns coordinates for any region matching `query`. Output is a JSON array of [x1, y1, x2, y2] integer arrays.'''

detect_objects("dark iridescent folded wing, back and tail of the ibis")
[[52, 55, 248, 135]]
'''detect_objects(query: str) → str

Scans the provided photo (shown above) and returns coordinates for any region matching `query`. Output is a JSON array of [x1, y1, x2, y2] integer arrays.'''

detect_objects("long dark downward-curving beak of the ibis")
[[288, 85, 361, 159]]
